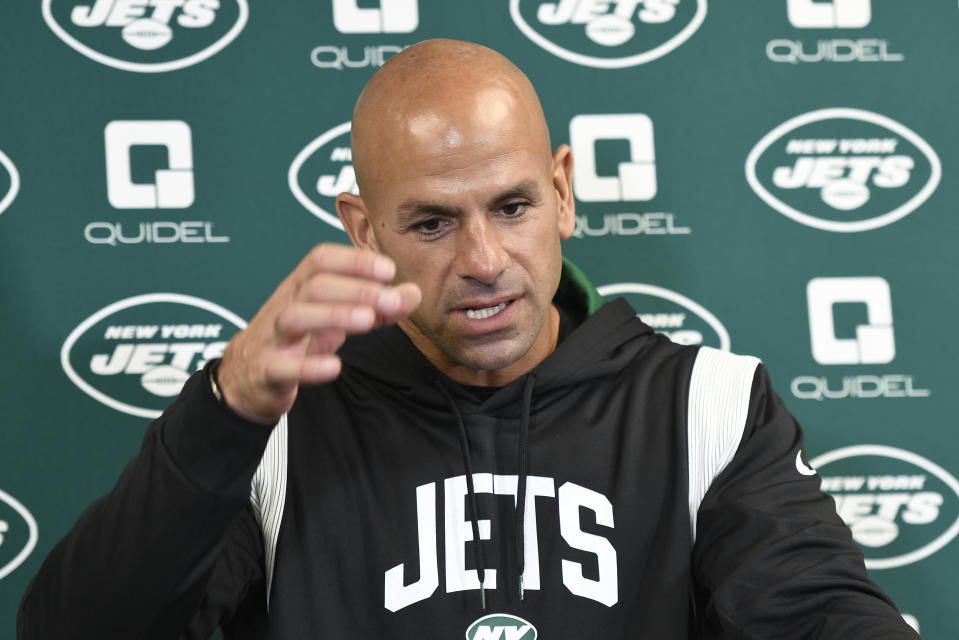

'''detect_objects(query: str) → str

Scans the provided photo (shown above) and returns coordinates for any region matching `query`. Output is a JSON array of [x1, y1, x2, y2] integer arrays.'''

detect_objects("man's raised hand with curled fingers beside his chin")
[[217, 244, 421, 424]]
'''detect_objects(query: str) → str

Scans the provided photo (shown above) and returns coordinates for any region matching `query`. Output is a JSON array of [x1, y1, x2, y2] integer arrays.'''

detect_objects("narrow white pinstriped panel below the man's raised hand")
[[250, 414, 287, 608]]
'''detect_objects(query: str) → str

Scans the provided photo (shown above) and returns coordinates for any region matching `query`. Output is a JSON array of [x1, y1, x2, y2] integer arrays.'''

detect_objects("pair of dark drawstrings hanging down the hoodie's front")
[[432, 374, 536, 611]]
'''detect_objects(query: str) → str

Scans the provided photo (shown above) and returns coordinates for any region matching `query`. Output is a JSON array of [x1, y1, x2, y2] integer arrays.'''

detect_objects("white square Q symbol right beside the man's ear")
[[569, 113, 656, 202]]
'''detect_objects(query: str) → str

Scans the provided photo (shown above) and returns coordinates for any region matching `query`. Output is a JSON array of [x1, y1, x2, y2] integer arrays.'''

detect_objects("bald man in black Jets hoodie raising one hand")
[[18, 40, 916, 640]]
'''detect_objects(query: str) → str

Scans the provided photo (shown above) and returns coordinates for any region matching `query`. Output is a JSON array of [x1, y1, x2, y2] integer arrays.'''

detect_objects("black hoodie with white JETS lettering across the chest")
[[18, 264, 917, 640]]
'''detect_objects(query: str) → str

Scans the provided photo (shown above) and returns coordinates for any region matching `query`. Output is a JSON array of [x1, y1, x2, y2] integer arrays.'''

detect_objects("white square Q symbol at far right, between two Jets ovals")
[[806, 277, 896, 364]]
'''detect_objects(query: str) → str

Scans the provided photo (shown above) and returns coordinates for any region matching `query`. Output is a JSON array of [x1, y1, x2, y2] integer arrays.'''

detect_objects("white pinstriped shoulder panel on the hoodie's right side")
[[686, 347, 759, 542]]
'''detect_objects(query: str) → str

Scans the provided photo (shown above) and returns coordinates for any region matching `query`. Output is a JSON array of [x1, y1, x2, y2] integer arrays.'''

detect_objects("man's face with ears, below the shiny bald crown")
[[348, 93, 573, 383]]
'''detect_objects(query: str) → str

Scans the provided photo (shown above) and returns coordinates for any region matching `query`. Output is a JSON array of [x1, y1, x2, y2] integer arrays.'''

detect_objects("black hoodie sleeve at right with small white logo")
[[693, 366, 919, 640]]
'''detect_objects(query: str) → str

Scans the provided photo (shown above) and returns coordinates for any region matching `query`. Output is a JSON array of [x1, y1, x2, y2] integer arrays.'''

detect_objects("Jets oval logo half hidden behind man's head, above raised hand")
[[287, 122, 359, 230]]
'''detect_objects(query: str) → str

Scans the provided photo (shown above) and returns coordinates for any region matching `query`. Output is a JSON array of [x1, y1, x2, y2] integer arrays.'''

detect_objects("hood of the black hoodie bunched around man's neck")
[[339, 259, 653, 417]]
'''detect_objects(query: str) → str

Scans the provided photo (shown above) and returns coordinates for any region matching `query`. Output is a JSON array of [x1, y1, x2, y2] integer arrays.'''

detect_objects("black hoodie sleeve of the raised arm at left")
[[17, 370, 271, 640]]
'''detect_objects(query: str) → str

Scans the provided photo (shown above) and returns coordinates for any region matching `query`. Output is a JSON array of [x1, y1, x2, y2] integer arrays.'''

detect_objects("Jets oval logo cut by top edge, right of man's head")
[[509, 0, 706, 69]]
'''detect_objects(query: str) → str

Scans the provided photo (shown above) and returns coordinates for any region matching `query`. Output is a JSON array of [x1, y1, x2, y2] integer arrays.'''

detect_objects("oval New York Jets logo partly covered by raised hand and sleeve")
[[60, 293, 246, 418]]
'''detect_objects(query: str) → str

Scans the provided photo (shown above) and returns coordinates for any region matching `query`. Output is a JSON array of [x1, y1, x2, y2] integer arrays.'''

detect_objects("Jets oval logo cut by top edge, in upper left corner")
[[43, 0, 249, 73]]
